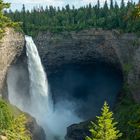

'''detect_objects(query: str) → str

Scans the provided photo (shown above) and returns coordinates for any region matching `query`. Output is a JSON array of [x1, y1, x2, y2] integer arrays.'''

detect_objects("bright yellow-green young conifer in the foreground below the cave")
[[85, 102, 122, 140]]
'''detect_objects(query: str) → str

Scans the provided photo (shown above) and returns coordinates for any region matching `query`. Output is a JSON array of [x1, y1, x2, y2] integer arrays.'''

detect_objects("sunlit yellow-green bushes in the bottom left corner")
[[0, 99, 31, 140]]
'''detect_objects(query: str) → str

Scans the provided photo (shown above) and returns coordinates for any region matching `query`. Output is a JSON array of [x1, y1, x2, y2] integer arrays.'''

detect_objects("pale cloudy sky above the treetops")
[[4, 0, 138, 10]]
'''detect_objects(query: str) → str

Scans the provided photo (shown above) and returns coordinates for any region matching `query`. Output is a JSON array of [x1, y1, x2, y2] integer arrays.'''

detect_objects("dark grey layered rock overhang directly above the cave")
[[35, 30, 120, 72]]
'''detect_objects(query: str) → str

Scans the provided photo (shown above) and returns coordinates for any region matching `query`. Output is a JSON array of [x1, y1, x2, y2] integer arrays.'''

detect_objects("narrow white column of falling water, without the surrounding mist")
[[25, 36, 51, 112]]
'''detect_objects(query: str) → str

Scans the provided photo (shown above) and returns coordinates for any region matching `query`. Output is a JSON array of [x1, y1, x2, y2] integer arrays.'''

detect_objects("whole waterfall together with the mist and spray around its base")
[[7, 36, 81, 140]]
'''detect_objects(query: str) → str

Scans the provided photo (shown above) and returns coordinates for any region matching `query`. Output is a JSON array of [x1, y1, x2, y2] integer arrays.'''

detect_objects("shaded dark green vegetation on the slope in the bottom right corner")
[[114, 84, 140, 140]]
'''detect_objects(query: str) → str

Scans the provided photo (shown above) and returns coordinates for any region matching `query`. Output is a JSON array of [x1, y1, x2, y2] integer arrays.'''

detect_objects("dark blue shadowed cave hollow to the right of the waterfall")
[[46, 61, 123, 120]]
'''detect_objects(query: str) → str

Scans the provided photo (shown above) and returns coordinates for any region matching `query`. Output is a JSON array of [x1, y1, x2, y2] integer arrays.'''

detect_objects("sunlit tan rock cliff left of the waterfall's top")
[[0, 28, 24, 96]]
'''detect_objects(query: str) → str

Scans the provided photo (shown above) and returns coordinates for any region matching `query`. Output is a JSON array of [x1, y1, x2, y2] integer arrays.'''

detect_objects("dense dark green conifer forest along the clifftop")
[[5, 0, 140, 35]]
